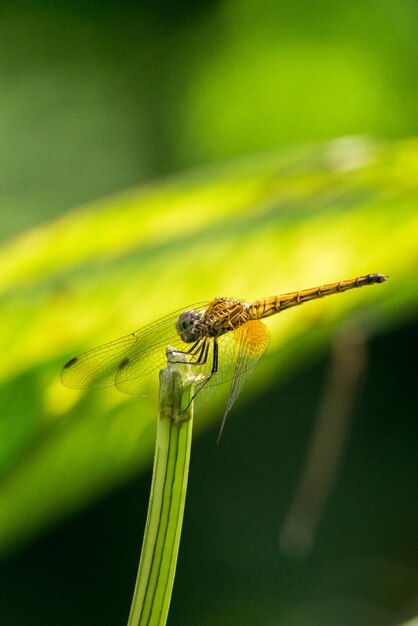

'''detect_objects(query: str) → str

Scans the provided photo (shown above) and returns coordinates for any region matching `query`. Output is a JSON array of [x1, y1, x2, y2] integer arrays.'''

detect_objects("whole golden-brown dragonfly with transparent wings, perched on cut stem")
[[61, 274, 388, 432]]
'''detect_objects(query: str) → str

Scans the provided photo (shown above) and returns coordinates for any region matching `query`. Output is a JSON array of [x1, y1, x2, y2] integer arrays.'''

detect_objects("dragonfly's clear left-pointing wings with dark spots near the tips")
[[61, 303, 207, 394]]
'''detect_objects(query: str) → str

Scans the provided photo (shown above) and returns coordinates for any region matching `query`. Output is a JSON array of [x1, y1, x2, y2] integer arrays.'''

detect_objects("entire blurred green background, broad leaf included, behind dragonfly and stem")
[[0, 0, 418, 626]]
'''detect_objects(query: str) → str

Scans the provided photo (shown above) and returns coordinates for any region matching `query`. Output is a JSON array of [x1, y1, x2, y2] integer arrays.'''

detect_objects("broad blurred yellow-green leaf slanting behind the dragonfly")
[[0, 138, 418, 551]]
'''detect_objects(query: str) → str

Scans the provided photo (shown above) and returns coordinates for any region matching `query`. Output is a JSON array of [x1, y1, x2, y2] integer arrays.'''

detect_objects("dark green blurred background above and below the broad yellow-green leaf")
[[0, 0, 418, 626]]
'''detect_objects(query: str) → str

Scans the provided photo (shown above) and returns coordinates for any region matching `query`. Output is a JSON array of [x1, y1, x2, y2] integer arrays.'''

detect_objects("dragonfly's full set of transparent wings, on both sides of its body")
[[61, 303, 269, 421]]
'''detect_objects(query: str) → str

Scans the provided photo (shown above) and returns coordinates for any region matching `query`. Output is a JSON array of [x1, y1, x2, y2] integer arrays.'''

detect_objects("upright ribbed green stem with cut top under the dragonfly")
[[128, 348, 194, 626]]
